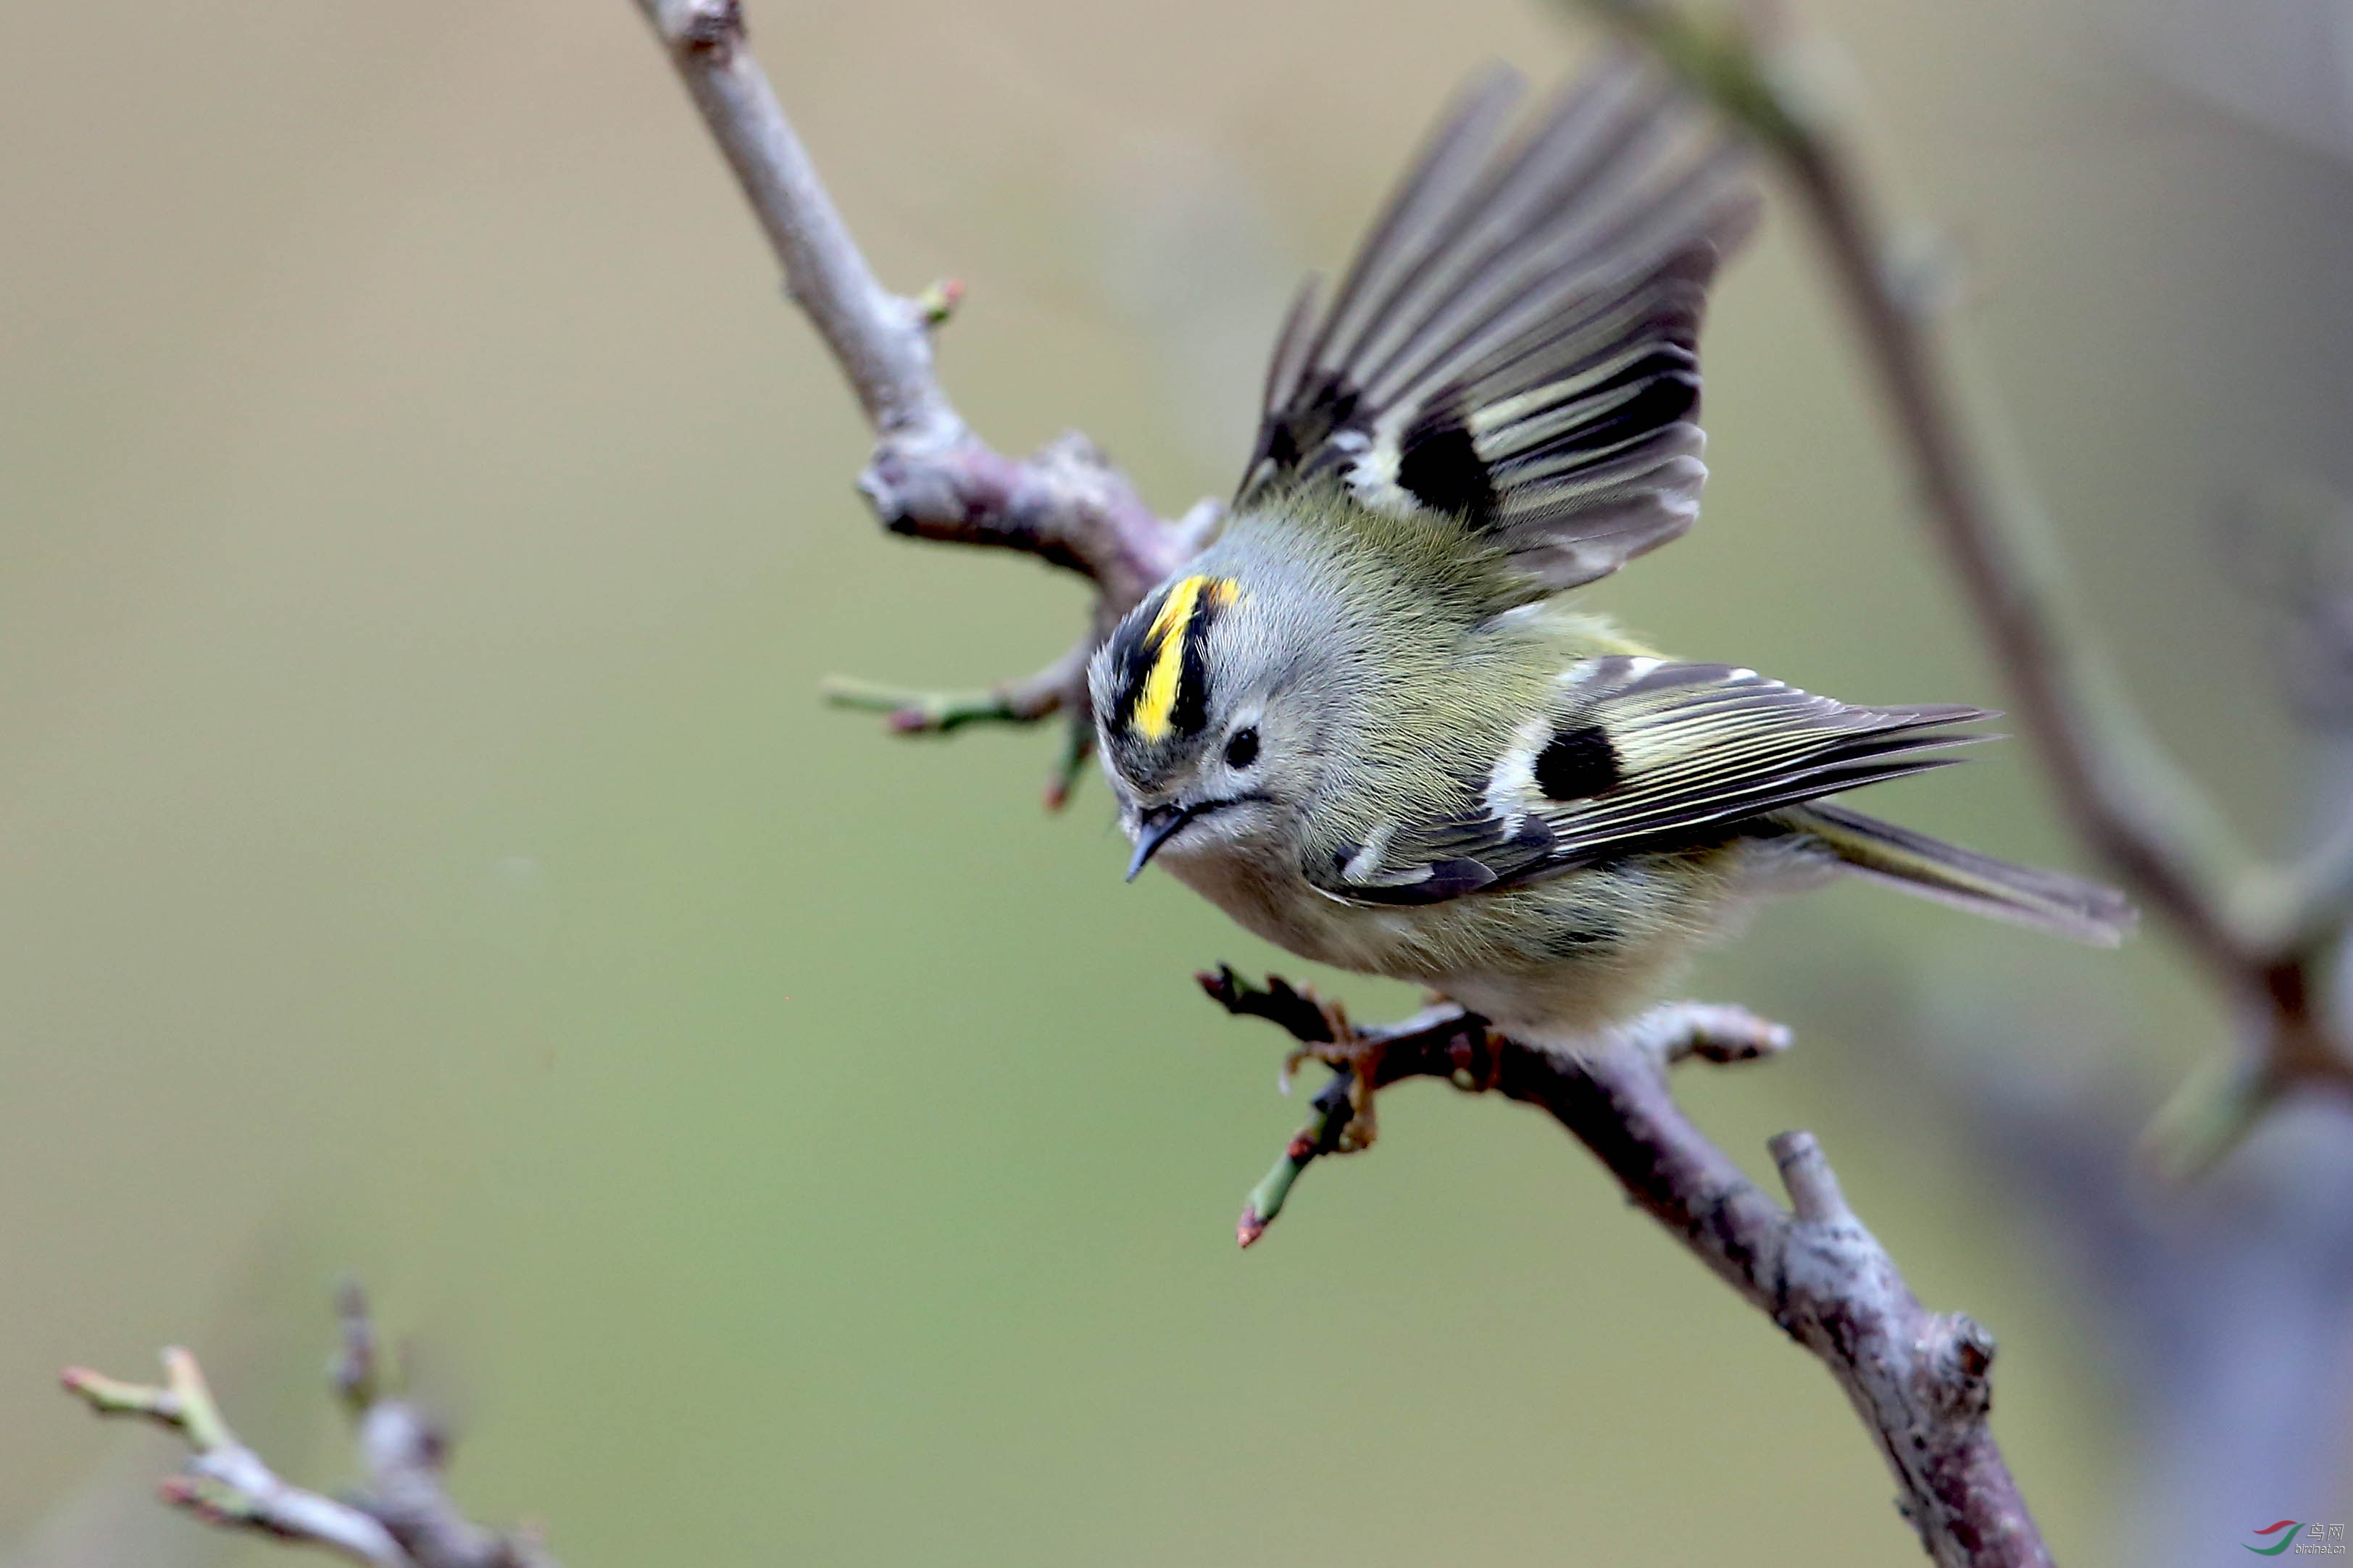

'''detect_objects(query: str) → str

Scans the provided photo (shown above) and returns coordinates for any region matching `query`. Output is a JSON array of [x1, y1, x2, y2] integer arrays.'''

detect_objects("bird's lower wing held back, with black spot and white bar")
[[1304, 654, 1988, 904]]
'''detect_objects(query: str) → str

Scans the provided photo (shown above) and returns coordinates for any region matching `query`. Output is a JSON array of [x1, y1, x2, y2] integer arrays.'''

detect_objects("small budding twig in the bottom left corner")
[[64, 1285, 558, 1568]]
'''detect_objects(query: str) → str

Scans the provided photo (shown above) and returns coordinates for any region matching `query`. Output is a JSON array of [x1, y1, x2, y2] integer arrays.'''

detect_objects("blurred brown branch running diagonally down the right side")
[[1581, 0, 2353, 1154]]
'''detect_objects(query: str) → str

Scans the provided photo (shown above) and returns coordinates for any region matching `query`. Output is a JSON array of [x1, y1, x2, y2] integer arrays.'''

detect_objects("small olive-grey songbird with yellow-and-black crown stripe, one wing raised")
[[1087, 59, 2134, 1048]]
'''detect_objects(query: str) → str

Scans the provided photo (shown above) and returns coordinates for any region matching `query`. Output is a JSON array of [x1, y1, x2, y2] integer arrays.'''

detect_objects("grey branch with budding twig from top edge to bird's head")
[[638, 0, 1217, 805]]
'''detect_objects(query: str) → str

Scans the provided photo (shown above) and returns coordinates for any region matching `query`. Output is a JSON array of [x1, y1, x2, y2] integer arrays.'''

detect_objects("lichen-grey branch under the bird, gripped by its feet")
[[1200, 970, 2049, 1568]]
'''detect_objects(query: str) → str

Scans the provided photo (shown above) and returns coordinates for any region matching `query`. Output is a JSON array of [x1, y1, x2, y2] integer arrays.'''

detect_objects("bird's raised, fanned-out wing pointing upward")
[[1240, 57, 1758, 591]]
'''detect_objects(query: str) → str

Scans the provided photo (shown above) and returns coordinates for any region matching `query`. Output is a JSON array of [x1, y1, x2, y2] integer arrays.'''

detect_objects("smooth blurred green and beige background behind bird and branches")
[[0, 0, 2353, 1568]]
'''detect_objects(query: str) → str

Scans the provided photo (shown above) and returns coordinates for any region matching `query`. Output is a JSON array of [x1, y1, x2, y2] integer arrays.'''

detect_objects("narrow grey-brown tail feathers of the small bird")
[[1781, 801, 2141, 946]]
